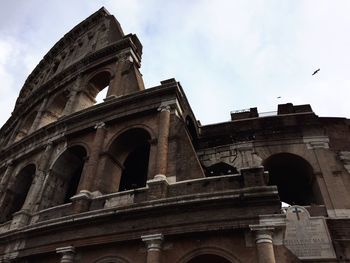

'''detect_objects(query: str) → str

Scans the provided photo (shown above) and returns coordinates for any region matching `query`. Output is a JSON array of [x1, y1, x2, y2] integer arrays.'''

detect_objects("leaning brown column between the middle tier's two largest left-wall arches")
[[78, 122, 106, 192]]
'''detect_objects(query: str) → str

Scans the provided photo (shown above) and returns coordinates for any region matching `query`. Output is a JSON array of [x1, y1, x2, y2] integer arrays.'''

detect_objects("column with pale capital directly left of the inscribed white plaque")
[[252, 227, 276, 263]]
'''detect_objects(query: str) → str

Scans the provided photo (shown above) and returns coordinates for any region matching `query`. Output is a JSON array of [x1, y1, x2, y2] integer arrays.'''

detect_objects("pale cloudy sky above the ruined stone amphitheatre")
[[0, 0, 350, 126]]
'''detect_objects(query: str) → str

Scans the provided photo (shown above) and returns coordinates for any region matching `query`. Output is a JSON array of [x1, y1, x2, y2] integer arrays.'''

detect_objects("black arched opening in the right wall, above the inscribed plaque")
[[264, 153, 323, 205]]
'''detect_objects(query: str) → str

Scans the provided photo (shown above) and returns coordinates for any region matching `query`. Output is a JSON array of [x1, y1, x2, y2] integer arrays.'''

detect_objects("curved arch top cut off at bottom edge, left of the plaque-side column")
[[177, 247, 240, 263]]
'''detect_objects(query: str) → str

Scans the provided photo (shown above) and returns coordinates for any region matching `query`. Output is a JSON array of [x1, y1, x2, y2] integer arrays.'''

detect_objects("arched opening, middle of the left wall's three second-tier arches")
[[41, 146, 87, 208]]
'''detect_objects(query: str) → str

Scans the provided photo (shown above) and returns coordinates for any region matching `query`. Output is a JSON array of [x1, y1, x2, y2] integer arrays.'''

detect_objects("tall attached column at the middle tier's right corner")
[[155, 105, 170, 178]]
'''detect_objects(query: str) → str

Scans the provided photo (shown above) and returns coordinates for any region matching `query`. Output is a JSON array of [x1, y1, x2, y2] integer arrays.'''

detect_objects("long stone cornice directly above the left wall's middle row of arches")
[[0, 85, 189, 161]]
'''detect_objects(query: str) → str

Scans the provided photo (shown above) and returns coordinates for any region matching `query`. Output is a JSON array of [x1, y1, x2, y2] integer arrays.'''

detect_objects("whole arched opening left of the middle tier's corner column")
[[105, 128, 151, 192]]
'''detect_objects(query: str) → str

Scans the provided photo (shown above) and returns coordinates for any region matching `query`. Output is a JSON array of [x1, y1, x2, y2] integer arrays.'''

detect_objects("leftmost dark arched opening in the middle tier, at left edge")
[[0, 164, 36, 222]]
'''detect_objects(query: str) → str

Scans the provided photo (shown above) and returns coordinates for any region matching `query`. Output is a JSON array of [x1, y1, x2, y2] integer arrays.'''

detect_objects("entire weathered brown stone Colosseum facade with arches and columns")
[[0, 8, 350, 263]]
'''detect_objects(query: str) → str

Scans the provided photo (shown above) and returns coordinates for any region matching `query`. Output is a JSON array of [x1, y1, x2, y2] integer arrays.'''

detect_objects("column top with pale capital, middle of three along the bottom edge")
[[141, 234, 163, 263]]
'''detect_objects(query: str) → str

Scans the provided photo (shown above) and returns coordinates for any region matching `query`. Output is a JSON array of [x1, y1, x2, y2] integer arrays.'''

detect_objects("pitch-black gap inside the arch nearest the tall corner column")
[[119, 143, 150, 191]]
